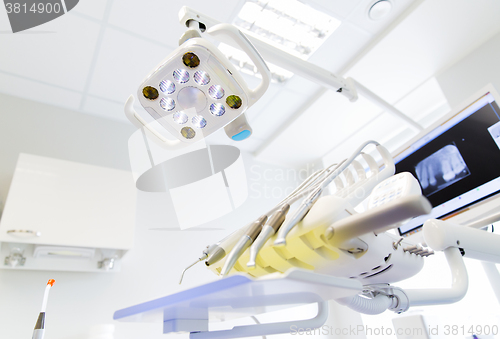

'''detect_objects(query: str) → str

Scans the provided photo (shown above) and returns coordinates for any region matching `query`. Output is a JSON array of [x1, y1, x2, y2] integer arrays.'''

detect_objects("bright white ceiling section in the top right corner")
[[349, 0, 500, 103]]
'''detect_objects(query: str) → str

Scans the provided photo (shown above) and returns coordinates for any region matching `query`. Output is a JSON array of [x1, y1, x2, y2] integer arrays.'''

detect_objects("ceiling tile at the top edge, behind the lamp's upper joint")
[[109, 0, 241, 47]]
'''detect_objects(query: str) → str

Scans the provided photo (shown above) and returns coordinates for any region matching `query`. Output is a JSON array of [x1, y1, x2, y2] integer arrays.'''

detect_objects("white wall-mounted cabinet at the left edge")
[[0, 154, 136, 271]]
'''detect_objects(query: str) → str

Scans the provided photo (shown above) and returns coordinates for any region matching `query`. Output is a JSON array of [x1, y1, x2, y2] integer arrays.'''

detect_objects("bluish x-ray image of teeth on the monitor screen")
[[415, 143, 470, 197]]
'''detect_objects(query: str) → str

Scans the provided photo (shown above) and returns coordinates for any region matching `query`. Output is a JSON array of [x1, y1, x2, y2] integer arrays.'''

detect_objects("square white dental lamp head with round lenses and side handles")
[[125, 17, 270, 148]]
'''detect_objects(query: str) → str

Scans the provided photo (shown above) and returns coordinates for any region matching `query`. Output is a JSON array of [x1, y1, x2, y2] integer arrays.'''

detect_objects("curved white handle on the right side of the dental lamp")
[[206, 24, 271, 107]]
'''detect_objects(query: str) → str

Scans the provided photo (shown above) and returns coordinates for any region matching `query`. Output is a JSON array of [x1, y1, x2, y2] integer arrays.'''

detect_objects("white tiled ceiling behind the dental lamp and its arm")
[[0, 0, 500, 165]]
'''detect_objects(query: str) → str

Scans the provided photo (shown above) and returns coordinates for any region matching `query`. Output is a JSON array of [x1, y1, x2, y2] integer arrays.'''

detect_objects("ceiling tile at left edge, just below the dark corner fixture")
[[0, 16, 99, 91]]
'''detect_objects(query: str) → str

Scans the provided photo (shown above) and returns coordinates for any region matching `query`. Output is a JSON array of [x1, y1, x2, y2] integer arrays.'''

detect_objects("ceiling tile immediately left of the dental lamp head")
[[89, 28, 172, 103]]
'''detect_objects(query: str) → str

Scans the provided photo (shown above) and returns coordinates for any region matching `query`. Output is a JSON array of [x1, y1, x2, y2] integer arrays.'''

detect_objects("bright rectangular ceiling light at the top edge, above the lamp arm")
[[234, 0, 341, 59]]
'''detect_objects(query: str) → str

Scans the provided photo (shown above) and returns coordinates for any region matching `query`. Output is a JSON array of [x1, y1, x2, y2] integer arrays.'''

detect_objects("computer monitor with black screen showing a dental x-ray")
[[394, 85, 500, 236]]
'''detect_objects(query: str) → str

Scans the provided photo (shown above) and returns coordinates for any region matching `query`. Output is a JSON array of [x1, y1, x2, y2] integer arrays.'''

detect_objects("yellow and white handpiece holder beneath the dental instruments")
[[209, 145, 395, 277]]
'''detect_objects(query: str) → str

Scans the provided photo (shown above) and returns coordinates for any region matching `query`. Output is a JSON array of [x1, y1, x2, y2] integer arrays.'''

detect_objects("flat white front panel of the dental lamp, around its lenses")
[[137, 38, 249, 143]]
